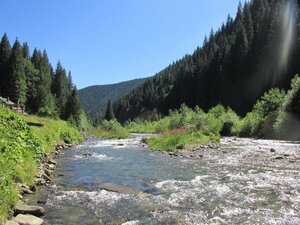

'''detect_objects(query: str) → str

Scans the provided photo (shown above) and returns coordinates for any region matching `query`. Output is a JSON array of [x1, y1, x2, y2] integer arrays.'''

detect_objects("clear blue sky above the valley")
[[0, 0, 244, 88]]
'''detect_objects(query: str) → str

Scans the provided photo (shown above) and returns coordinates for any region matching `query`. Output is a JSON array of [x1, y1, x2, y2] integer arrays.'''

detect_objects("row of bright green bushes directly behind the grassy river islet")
[[125, 104, 239, 136]]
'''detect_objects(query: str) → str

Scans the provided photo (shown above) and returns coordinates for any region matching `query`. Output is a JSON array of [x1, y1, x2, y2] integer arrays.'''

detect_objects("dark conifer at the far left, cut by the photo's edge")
[[0, 33, 11, 97]]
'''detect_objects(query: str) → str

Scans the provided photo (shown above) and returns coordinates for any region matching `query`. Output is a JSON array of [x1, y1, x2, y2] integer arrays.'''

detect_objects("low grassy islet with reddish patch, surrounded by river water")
[[144, 131, 220, 151]]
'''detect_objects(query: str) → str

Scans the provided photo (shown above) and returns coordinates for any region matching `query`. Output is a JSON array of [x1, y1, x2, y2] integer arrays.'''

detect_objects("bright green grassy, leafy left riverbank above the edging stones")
[[0, 104, 82, 224]]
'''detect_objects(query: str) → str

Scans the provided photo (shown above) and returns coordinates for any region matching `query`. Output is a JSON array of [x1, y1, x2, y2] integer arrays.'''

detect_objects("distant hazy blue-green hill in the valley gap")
[[79, 79, 146, 120]]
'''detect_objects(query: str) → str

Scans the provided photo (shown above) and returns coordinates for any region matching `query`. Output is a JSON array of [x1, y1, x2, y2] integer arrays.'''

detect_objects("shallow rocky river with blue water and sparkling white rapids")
[[27, 135, 300, 225]]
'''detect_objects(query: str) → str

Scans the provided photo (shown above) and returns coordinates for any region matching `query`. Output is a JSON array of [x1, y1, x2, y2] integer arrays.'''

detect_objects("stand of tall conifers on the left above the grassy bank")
[[0, 34, 84, 126]]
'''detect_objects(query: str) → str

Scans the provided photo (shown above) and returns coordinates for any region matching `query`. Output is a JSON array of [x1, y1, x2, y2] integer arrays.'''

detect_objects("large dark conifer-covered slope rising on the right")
[[114, 0, 300, 122]]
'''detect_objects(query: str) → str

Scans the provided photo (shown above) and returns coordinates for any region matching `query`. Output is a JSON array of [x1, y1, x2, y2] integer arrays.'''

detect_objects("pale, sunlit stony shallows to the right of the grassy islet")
[[167, 137, 300, 170]]
